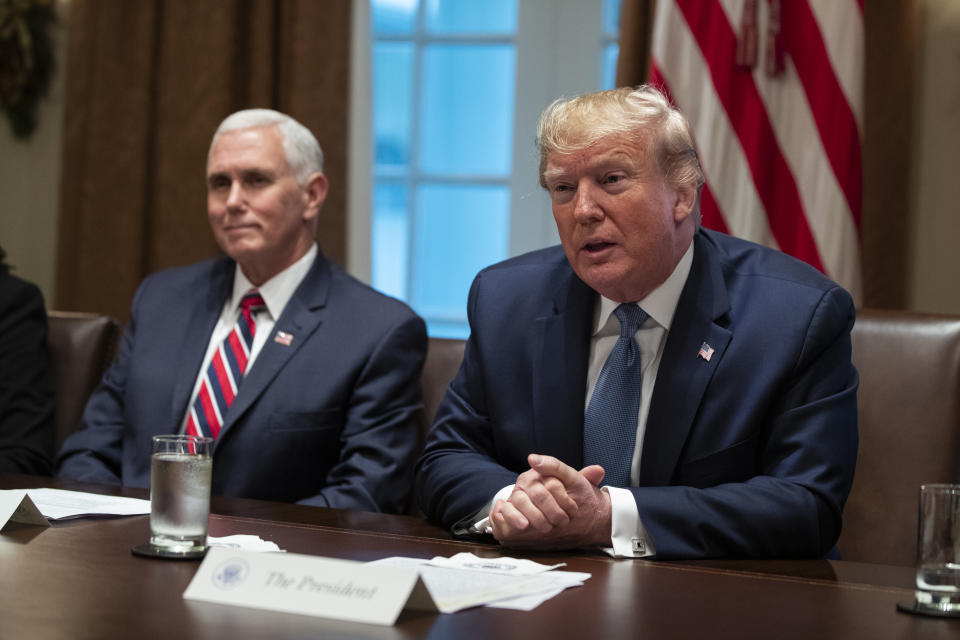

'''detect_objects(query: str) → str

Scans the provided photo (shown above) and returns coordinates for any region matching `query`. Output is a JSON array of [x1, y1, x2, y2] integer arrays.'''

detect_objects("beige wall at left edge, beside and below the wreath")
[[0, 0, 69, 307]]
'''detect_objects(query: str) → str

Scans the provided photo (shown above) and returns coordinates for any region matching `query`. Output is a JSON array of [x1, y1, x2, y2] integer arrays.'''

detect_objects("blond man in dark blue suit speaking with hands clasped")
[[416, 87, 858, 558]]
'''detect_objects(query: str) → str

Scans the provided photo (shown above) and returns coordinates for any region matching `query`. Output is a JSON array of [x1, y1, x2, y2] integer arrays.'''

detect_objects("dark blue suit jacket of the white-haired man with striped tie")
[[58, 254, 426, 512]]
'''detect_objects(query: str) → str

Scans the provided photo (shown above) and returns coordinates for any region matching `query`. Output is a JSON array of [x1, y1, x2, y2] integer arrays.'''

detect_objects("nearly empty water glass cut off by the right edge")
[[916, 484, 960, 615]]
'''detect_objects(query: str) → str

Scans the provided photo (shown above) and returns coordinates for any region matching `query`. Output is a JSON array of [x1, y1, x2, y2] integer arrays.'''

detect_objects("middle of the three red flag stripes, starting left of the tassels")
[[676, 0, 823, 271]]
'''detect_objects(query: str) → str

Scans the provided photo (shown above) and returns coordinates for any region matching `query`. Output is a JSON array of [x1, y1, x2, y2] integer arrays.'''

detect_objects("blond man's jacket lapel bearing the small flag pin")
[[640, 233, 732, 486]]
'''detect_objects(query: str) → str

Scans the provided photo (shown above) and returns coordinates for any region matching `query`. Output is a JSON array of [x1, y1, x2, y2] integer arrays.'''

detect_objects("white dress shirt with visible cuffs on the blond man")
[[470, 242, 693, 558]]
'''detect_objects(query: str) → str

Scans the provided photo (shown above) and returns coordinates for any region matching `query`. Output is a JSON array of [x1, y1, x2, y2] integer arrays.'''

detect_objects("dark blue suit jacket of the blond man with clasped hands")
[[417, 230, 858, 558]]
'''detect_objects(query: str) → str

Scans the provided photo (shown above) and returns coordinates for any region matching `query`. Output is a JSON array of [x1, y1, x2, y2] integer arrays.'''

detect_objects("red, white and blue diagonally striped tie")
[[187, 289, 266, 438]]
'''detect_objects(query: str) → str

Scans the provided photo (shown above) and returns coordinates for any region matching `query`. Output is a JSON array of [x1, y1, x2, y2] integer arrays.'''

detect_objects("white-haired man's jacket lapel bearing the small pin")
[[217, 253, 331, 443]]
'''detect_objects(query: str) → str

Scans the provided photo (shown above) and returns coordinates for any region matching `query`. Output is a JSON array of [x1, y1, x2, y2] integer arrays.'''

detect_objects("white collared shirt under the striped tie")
[[180, 243, 318, 433]]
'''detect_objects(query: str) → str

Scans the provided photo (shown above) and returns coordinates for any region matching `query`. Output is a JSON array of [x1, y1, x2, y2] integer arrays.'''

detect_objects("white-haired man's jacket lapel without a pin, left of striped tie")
[[170, 258, 235, 429]]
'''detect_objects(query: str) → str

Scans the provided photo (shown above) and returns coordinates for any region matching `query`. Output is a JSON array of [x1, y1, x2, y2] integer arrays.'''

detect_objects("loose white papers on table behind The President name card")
[[370, 557, 590, 613]]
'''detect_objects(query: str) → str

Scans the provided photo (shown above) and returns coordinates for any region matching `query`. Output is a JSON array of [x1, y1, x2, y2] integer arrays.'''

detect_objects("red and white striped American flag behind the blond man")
[[650, 0, 864, 302]]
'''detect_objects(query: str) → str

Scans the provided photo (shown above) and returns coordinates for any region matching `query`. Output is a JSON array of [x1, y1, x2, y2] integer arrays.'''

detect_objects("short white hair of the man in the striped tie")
[[207, 109, 323, 187]]
